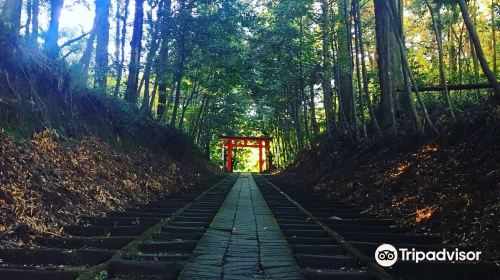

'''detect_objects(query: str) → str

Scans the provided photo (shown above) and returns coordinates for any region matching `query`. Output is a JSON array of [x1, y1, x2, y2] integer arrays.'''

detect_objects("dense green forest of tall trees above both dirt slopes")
[[1, 0, 500, 166]]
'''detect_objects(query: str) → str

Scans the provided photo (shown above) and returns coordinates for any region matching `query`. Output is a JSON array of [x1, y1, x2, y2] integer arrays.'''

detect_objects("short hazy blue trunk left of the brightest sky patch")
[[43, 0, 64, 58]]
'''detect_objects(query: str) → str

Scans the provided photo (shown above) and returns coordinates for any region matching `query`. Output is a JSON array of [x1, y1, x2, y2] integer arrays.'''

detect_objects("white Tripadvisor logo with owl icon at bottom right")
[[375, 244, 481, 267]]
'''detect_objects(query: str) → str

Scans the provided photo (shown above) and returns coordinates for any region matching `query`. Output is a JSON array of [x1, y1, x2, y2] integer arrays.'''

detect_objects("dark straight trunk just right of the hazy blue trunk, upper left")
[[125, 0, 144, 105]]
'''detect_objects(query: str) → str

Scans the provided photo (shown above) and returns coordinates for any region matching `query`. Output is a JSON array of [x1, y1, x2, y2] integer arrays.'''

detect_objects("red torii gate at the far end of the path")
[[219, 136, 273, 173]]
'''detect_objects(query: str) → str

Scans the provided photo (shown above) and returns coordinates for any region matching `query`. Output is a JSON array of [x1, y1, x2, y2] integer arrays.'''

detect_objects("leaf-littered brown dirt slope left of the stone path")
[[0, 130, 211, 246]]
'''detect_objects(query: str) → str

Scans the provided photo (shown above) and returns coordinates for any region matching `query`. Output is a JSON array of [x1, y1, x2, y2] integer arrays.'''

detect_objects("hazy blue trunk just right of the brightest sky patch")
[[94, 0, 111, 94]]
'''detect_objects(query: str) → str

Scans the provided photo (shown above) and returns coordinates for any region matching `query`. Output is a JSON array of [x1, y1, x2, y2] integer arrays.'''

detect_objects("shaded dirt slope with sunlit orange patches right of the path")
[[278, 105, 500, 261]]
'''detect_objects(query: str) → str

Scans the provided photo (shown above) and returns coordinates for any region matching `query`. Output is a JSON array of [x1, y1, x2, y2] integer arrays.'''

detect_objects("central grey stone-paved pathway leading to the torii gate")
[[179, 174, 302, 279]]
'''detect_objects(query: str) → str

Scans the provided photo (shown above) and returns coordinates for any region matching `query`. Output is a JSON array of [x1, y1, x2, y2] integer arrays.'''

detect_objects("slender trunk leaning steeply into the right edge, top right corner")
[[456, 0, 500, 100]]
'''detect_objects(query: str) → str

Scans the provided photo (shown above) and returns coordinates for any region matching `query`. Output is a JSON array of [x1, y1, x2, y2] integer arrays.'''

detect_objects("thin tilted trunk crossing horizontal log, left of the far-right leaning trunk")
[[424, 0, 455, 119]]
